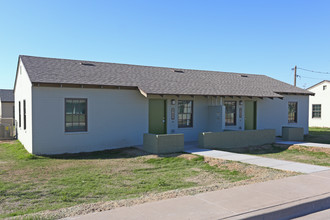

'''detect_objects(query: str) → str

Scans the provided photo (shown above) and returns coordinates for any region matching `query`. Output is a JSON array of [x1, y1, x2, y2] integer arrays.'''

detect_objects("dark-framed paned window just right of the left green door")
[[178, 100, 193, 128]]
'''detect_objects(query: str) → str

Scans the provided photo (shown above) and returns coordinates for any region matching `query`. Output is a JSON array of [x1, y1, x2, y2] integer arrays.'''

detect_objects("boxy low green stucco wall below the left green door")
[[143, 134, 184, 154]]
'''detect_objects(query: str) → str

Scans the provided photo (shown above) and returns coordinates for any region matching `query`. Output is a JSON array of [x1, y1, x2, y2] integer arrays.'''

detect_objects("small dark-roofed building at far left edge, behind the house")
[[0, 89, 14, 125]]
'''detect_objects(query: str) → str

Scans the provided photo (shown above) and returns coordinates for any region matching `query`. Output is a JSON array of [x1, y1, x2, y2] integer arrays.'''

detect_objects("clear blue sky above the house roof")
[[0, 0, 330, 89]]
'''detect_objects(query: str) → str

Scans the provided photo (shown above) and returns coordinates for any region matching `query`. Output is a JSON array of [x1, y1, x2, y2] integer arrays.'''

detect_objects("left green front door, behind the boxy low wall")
[[149, 99, 166, 134]]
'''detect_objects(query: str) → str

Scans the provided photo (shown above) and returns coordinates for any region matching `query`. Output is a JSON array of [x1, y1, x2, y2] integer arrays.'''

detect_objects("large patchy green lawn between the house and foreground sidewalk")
[[0, 141, 295, 218]]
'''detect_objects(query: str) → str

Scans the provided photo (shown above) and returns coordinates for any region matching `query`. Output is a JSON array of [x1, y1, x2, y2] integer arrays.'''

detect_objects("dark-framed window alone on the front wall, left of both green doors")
[[65, 99, 87, 132]]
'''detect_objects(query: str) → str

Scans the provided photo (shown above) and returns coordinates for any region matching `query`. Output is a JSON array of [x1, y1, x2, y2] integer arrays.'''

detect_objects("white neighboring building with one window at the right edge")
[[308, 80, 330, 127]]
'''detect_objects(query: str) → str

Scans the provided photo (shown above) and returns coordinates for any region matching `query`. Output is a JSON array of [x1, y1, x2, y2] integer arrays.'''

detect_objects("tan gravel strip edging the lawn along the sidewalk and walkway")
[[11, 156, 298, 219]]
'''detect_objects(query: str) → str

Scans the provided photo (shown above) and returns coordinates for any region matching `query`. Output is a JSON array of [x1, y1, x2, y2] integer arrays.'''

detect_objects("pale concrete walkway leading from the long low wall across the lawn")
[[185, 142, 330, 173]]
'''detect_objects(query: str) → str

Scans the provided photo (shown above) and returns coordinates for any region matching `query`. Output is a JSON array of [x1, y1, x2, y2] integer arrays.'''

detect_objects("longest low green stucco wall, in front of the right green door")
[[198, 129, 275, 149]]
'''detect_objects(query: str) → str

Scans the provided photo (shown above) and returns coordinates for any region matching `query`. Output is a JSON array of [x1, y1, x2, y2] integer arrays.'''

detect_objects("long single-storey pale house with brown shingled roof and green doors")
[[14, 56, 312, 154]]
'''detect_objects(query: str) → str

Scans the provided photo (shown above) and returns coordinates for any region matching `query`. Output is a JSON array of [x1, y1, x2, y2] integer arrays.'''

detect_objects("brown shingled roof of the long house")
[[20, 56, 313, 97]]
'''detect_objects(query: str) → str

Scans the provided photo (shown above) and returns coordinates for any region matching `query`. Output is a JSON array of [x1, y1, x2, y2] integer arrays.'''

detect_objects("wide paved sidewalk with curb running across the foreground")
[[67, 171, 330, 220]]
